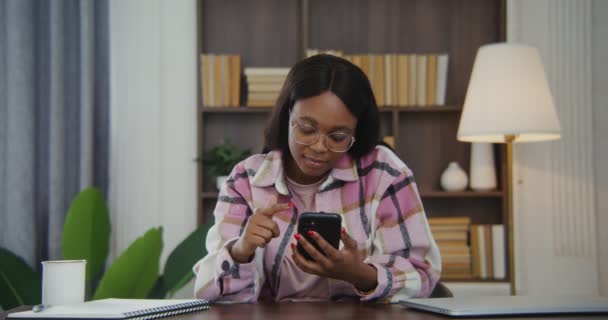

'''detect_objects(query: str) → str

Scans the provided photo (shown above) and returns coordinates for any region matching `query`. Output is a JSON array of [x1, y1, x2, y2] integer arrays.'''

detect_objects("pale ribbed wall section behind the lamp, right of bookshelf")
[[507, 0, 605, 295]]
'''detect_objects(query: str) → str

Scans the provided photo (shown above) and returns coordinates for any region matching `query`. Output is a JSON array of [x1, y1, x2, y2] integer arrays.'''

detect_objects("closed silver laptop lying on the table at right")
[[400, 296, 608, 317]]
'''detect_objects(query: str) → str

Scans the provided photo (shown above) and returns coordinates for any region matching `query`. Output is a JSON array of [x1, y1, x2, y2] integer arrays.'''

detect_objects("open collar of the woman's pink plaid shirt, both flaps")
[[251, 150, 359, 195]]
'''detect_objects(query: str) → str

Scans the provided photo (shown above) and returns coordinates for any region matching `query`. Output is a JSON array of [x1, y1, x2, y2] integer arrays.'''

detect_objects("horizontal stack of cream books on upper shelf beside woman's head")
[[245, 68, 289, 107]]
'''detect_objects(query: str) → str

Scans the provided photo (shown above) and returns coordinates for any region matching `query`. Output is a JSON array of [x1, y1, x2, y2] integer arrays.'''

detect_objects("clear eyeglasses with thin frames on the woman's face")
[[291, 120, 355, 152]]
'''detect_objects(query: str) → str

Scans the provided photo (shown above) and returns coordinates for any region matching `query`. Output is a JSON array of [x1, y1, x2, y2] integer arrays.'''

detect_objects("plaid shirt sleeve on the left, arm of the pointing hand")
[[193, 165, 264, 302]]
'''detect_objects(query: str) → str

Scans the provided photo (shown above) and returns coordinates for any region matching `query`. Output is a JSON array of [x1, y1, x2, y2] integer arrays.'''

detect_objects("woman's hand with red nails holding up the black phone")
[[291, 229, 378, 292]]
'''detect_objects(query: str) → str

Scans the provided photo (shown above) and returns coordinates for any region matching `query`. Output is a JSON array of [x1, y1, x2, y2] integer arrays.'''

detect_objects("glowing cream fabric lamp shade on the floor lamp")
[[458, 43, 560, 142]]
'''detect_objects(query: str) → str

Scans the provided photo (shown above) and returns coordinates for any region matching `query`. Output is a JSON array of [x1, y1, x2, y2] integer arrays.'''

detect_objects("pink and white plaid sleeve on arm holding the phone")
[[356, 169, 441, 303]]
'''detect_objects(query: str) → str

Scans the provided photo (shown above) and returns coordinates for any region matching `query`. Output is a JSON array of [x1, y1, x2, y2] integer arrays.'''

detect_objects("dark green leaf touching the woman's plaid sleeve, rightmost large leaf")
[[163, 221, 213, 295]]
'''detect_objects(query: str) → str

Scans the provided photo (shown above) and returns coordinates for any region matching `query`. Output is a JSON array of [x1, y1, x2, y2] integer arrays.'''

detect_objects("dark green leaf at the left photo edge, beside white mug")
[[0, 248, 42, 310]]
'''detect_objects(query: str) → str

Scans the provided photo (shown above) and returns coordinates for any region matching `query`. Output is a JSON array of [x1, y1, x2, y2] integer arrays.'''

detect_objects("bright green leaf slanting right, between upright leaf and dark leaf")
[[93, 227, 163, 300]]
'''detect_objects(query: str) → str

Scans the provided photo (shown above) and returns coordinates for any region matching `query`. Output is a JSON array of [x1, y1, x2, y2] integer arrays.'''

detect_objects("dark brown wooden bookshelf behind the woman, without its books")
[[197, 0, 511, 283]]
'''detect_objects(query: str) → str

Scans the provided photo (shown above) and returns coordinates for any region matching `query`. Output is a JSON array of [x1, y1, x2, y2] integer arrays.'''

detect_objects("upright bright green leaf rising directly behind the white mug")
[[61, 187, 110, 287]]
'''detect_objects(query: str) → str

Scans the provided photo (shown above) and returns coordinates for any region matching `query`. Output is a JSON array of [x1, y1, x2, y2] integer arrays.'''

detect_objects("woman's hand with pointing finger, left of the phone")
[[230, 203, 293, 263]]
